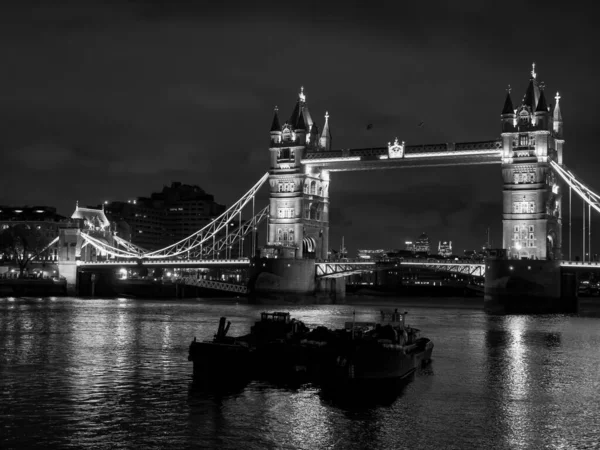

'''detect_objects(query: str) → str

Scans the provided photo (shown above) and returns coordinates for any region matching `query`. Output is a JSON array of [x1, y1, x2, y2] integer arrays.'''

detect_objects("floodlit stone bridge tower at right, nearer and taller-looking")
[[501, 63, 564, 260]]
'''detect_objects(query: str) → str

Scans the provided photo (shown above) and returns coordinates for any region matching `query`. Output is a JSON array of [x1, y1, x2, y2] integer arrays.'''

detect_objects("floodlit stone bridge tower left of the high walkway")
[[261, 88, 331, 259]]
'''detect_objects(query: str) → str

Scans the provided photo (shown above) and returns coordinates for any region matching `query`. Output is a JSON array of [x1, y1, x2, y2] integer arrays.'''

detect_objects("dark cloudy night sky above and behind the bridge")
[[0, 0, 600, 254]]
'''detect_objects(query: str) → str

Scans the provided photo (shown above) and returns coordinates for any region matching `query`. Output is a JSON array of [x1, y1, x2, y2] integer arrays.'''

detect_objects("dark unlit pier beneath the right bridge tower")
[[484, 259, 578, 314]]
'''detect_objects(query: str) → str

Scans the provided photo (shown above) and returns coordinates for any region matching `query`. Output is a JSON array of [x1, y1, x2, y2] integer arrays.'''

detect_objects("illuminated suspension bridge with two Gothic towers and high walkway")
[[50, 65, 600, 312]]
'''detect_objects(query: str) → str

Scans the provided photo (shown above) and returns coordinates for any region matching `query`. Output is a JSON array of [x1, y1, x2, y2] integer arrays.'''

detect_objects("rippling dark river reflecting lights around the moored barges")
[[0, 298, 600, 449]]
